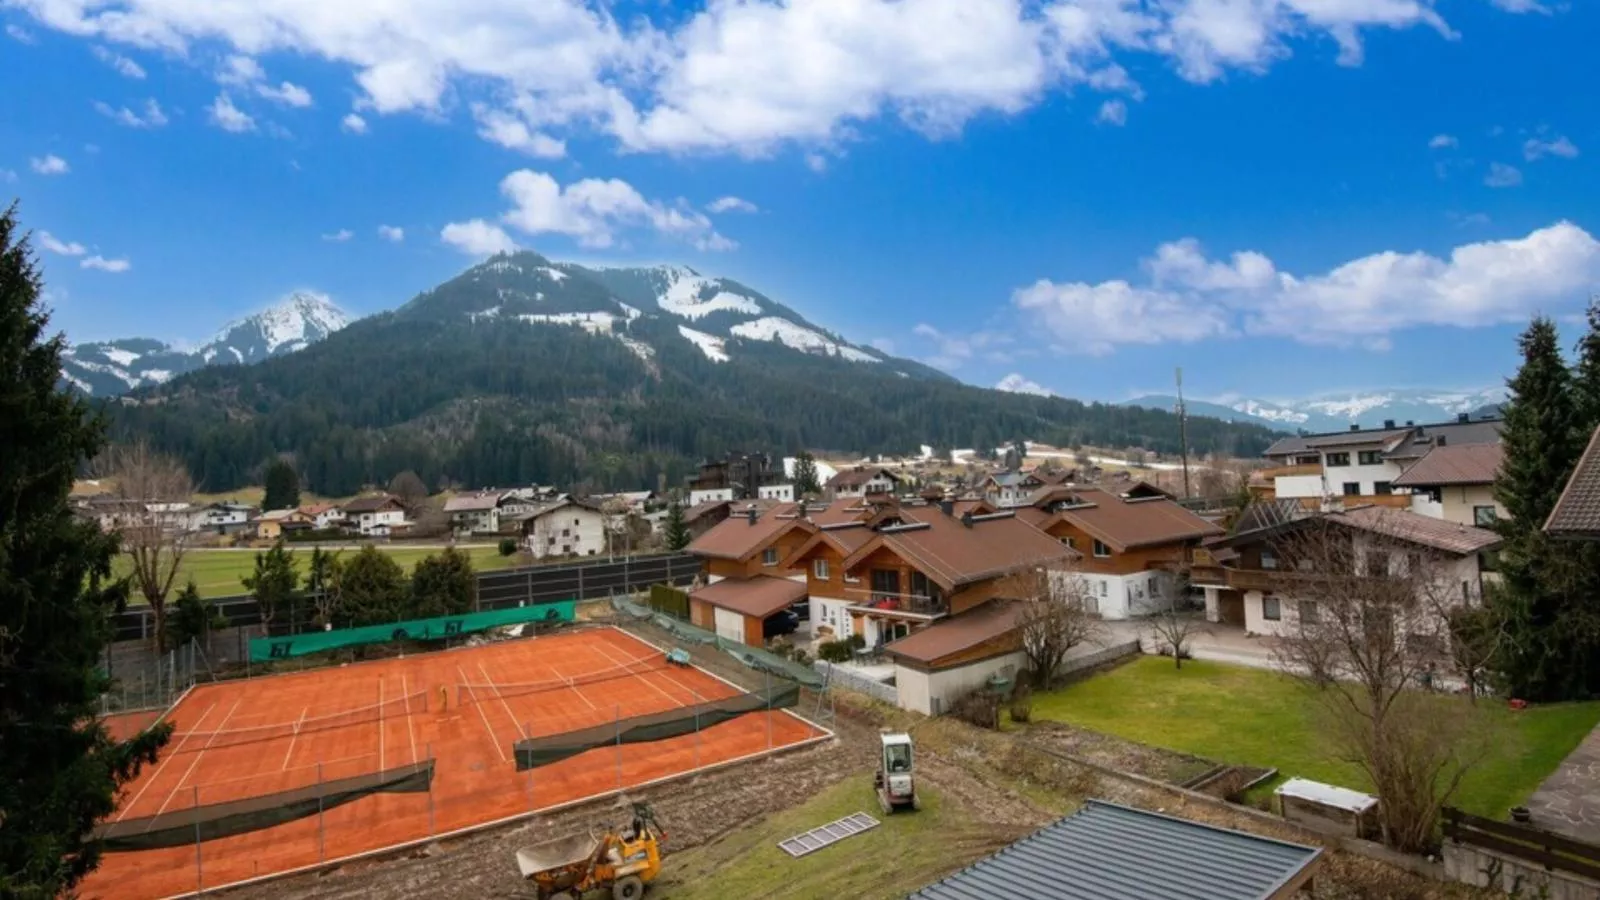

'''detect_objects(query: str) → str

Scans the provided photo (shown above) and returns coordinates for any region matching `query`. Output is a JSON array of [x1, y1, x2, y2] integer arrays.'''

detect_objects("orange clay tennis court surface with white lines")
[[82, 628, 829, 900]]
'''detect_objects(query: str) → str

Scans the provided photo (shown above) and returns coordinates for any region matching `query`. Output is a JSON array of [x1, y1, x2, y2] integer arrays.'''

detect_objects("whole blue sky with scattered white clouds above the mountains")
[[0, 0, 1600, 399]]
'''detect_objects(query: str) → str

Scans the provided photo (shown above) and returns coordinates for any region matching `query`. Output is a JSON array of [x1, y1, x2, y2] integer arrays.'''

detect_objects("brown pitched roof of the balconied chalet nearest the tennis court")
[[845, 506, 1078, 591]]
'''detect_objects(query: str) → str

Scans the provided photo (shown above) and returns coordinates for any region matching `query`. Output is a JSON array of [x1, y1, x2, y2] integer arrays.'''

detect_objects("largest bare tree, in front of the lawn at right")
[[1275, 512, 1491, 852]]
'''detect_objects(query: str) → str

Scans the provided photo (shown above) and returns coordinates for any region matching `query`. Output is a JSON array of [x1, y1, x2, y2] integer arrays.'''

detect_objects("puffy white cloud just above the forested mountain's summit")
[[501, 168, 738, 250]]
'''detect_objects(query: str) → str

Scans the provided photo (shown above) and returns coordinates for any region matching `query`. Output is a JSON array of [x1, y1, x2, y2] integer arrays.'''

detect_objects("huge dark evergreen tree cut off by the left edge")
[[0, 207, 171, 900]]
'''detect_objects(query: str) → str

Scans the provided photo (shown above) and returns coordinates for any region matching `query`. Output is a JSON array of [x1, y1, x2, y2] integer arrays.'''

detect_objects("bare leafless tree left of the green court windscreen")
[[94, 440, 195, 649]]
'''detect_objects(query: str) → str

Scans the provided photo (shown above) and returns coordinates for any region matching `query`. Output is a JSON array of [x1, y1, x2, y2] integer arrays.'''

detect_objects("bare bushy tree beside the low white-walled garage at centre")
[[1000, 567, 1104, 689]]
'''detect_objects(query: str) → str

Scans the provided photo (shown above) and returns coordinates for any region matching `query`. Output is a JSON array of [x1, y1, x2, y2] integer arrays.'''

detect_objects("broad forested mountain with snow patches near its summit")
[[100, 253, 1270, 495]]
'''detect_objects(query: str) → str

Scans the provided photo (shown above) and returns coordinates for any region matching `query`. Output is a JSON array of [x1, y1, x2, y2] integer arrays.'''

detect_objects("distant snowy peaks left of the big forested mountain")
[[61, 291, 350, 397]]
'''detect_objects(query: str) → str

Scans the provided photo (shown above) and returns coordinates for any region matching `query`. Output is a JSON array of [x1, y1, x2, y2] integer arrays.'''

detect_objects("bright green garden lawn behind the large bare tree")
[[1034, 657, 1600, 818]]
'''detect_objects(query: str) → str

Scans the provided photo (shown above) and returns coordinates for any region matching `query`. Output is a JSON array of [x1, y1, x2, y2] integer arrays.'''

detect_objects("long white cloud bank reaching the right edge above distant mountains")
[[1011, 221, 1600, 354]]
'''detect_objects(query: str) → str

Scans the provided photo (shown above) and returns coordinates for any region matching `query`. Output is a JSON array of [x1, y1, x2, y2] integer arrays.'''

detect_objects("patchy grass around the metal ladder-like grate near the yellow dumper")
[[651, 770, 1003, 900]]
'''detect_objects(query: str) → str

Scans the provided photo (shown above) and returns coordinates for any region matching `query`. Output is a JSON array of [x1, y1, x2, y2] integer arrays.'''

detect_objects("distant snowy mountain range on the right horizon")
[[1123, 388, 1506, 432]]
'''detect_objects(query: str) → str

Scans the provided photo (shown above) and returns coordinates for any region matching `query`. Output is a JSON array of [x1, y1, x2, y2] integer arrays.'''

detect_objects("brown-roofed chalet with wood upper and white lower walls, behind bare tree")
[[1018, 482, 1226, 620]]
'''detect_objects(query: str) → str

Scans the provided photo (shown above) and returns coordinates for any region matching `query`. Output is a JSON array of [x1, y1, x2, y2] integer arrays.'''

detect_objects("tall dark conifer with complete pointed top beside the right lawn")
[[1486, 317, 1587, 700]]
